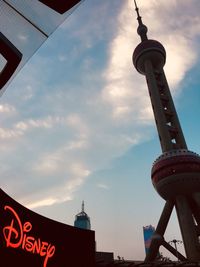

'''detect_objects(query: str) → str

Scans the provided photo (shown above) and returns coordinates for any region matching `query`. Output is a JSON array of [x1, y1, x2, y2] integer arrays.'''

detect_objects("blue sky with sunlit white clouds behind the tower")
[[0, 0, 200, 259]]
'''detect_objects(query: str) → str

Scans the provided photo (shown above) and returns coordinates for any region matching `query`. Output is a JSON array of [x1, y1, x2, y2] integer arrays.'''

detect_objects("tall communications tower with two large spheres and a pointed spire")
[[133, 0, 200, 261]]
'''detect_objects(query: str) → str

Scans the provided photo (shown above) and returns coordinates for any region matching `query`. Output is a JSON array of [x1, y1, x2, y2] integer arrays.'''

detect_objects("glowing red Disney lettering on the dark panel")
[[3, 206, 55, 267]]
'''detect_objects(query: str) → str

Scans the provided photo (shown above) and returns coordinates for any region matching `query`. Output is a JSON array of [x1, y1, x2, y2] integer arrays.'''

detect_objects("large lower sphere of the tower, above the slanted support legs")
[[151, 149, 200, 200]]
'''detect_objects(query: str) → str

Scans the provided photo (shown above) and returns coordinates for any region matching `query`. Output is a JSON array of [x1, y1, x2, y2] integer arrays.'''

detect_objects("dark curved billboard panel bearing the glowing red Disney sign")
[[0, 189, 95, 267]]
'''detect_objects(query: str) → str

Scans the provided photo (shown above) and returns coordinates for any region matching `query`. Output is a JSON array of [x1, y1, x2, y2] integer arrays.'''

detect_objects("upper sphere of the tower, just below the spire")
[[133, 40, 166, 75]]
